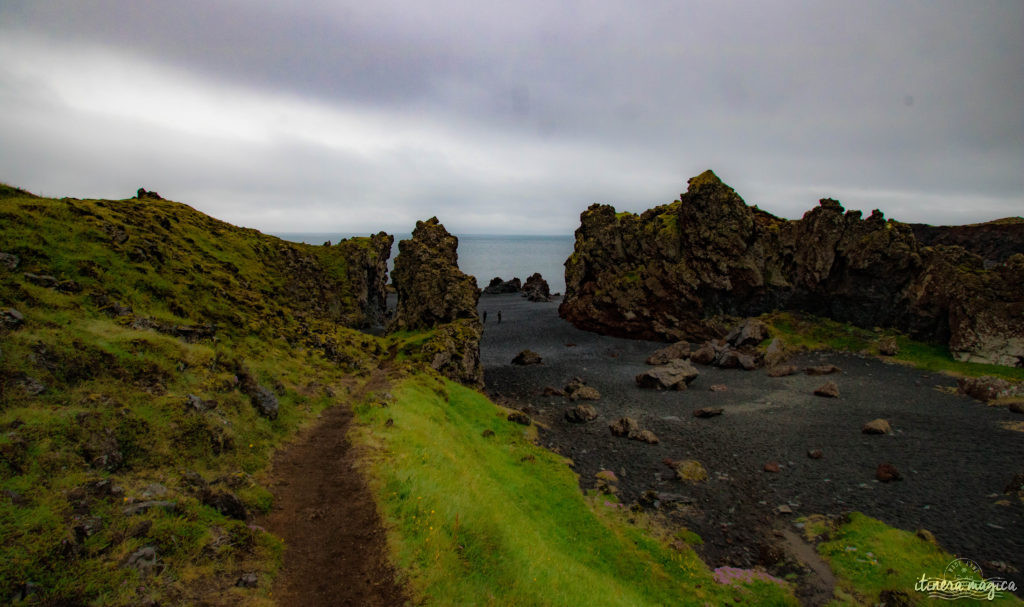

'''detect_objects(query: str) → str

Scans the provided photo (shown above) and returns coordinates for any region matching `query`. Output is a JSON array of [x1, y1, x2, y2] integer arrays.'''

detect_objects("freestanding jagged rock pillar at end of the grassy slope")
[[389, 217, 483, 387]]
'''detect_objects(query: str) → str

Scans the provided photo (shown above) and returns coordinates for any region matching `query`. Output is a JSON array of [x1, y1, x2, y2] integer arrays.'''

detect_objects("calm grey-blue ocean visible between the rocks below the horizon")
[[273, 232, 574, 293]]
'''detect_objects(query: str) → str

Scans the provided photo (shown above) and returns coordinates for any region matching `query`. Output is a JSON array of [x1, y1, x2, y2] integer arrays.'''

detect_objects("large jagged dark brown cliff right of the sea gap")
[[559, 171, 1024, 365]]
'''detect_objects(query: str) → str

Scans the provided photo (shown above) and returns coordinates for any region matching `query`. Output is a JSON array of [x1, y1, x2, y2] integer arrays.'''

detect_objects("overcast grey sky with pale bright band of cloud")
[[0, 0, 1024, 233]]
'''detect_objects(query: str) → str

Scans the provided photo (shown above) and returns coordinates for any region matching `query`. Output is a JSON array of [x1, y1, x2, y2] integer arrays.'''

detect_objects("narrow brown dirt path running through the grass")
[[259, 378, 406, 607]]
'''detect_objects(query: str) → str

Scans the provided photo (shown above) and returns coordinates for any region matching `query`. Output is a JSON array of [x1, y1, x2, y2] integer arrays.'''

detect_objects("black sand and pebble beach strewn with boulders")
[[479, 295, 1024, 588]]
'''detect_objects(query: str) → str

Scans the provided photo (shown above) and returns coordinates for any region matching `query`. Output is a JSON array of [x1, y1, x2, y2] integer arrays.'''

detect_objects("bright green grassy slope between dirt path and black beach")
[[353, 376, 795, 606]]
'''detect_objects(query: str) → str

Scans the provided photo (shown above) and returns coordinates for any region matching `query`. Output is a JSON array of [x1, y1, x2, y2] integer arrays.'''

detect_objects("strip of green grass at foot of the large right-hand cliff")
[[760, 312, 1024, 381]]
